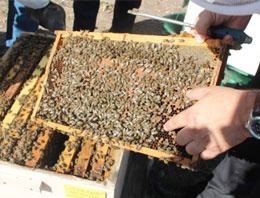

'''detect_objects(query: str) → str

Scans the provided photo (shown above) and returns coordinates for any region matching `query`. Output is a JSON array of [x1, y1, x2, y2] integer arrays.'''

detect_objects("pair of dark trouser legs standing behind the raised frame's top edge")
[[73, 0, 141, 33]]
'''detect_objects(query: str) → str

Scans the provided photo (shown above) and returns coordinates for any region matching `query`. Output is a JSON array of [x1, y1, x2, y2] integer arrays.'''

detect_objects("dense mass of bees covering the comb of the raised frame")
[[36, 36, 214, 159]]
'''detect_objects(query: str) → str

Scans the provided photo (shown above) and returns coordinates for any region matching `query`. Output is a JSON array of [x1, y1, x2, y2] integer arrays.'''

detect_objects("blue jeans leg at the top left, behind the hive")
[[6, 0, 38, 47]]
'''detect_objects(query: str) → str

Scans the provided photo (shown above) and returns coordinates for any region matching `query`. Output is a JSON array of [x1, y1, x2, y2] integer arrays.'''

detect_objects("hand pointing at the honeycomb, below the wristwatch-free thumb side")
[[164, 87, 257, 159]]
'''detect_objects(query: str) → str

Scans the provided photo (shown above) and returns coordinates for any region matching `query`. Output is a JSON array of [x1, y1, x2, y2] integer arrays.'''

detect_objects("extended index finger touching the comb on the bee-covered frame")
[[164, 109, 189, 131]]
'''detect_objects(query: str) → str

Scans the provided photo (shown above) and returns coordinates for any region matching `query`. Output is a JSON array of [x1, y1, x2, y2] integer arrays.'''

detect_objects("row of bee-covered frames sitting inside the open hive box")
[[0, 33, 127, 193]]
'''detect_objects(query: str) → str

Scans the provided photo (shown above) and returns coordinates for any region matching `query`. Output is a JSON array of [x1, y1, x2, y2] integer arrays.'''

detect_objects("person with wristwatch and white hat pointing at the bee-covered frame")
[[164, 0, 260, 198]]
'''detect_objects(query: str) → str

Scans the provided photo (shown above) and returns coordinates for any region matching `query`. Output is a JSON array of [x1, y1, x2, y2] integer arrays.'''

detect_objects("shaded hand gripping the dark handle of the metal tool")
[[191, 10, 251, 43]]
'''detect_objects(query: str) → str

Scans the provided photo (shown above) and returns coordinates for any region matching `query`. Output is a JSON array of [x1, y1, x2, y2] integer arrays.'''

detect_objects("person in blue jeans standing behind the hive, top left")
[[6, 0, 66, 47]]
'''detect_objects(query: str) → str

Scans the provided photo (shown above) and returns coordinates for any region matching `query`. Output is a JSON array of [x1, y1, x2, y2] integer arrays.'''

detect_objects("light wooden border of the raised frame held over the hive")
[[31, 31, 227, 167]]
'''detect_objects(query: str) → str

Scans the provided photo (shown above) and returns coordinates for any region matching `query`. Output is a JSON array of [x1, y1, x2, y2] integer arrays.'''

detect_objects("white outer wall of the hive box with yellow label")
[[0, 150, 129, 198]]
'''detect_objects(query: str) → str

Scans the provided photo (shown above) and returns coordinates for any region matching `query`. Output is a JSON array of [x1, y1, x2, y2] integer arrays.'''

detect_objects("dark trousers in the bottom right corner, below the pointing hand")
[[197, 138, 260, 198]]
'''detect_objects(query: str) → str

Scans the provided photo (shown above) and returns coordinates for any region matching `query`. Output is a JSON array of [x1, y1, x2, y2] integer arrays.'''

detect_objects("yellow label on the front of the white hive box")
[[64, 184, 106, 198]]
